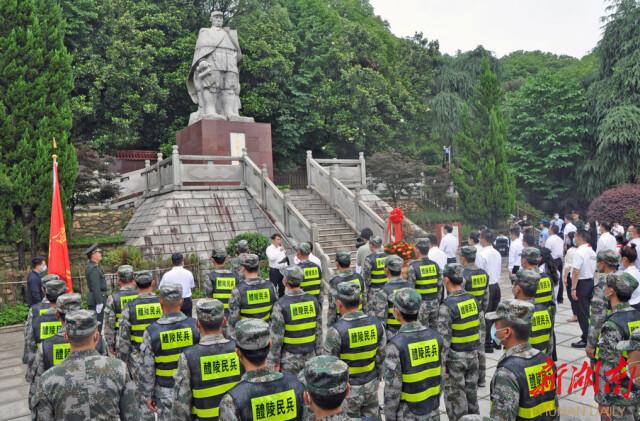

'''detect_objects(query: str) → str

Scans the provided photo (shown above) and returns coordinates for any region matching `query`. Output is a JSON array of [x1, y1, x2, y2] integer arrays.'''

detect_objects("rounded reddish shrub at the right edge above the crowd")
[[587, 184, 640, 226]]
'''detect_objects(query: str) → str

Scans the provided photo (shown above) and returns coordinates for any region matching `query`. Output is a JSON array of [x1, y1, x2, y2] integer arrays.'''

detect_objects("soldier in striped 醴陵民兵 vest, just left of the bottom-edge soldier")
[[168, 299, 242, 421]]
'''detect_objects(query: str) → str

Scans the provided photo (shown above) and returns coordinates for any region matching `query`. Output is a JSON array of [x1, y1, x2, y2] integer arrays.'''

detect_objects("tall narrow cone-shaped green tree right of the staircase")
[[452, 59, 515, 226]]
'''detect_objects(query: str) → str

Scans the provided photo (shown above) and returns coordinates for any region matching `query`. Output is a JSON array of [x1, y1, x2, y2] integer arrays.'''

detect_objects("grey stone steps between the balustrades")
[[289, 189, 358, 268]]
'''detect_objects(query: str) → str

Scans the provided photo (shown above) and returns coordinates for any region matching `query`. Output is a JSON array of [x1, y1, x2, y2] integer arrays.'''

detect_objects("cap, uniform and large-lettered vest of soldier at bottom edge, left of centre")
[[220, 319, 304, 421]]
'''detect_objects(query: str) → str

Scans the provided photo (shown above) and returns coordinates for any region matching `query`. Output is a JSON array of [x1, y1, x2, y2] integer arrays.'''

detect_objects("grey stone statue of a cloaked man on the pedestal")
[[187, 11, 253, 125]]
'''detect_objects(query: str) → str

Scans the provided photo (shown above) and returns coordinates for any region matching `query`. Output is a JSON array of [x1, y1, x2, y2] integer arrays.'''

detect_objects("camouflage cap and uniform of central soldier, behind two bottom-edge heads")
[[267, 266, 322, 374]]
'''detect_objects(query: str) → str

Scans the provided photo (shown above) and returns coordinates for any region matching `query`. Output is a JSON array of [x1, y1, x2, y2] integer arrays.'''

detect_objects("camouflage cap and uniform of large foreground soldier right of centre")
[[383, 288, 444, 421]]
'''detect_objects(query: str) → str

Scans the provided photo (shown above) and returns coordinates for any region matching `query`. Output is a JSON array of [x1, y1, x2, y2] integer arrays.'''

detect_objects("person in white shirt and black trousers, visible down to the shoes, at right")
[[571, 230, 596, 348]]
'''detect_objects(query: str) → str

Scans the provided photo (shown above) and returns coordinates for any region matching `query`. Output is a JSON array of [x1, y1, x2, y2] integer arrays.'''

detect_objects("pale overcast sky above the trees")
[[370, 0, 606, 58]]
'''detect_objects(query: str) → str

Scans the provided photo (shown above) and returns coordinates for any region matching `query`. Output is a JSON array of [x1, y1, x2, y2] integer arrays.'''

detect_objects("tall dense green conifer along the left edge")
[[0, 0, 77, 266]]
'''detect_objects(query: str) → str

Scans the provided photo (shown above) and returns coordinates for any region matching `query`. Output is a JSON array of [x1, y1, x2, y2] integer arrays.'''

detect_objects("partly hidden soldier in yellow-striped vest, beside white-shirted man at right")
[[460, 246, 489, 387]]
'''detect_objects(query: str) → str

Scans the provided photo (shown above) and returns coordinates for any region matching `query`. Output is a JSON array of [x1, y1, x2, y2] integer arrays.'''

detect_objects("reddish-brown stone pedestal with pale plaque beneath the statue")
[[176, 119, 273, 180]]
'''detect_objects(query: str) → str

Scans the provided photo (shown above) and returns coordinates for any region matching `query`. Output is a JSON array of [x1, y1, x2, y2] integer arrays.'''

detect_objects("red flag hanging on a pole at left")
[[48, 158, 73, 292]]
